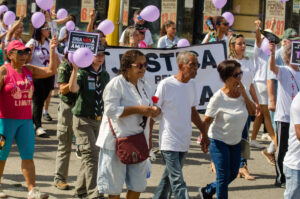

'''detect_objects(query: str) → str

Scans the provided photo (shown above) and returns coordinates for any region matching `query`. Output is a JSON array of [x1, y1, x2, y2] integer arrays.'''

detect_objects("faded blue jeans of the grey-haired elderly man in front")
[[153, 151, 189, 199]]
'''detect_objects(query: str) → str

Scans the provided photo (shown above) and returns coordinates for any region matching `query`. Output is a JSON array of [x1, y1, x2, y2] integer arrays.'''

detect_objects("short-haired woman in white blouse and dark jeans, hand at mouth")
[[199, 60, 255, 199]]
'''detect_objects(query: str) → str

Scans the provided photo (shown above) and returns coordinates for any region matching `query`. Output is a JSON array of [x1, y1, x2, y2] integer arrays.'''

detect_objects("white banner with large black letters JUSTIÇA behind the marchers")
[[105, 42, 227, 110]]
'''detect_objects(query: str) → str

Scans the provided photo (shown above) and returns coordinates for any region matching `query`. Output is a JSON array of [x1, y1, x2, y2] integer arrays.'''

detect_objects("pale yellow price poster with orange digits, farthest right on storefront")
[[265, 0, 285, 36]]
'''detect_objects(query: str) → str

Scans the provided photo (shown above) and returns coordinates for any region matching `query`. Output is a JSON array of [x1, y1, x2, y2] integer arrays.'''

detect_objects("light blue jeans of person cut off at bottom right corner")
[[283, 165, 300, 199]]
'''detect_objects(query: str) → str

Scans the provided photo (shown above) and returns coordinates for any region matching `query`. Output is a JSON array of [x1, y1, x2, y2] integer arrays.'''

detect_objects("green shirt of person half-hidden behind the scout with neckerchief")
[[57, 61, 77, 105]]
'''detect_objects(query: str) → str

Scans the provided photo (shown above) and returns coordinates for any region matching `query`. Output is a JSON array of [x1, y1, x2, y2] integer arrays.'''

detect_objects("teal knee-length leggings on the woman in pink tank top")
[[0, 118, 35, 160]]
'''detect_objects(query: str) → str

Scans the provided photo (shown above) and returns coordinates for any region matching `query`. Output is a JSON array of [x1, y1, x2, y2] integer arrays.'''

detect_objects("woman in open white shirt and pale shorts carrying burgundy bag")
[[96, 50, 160, 199]]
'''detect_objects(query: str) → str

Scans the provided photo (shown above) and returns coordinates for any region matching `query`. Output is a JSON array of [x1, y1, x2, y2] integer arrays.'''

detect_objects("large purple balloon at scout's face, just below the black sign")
[[73, 48, 94, 68]]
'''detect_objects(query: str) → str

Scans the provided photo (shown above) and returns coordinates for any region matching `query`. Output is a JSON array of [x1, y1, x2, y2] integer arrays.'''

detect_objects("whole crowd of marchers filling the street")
[[0, 5, 300, 199]]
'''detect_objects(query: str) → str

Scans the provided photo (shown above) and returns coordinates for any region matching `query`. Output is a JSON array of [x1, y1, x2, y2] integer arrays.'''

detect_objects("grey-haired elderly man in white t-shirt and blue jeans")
[[150, 51, 209, 199]]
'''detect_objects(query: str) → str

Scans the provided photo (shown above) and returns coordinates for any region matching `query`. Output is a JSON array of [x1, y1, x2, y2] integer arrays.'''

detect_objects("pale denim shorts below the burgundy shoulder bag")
[[97, 148, 147, 195]]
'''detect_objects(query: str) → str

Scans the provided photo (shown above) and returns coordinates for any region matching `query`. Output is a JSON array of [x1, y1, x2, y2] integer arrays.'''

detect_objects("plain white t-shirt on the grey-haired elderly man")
[[155, 76, 198, 152]]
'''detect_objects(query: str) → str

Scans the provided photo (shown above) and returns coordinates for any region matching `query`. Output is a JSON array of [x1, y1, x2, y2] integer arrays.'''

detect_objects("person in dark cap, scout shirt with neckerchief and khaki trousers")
[[69, 45, 110, 198]]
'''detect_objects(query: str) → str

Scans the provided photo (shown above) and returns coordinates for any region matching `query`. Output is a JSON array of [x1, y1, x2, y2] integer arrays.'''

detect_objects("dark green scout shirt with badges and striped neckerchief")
[[72, 66, 110, 118]]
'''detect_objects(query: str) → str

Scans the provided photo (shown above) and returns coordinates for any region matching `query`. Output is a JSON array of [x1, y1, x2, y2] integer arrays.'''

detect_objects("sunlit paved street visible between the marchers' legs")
[[2, 98, 284, 199]]
